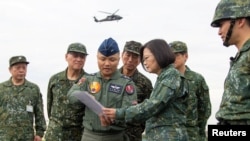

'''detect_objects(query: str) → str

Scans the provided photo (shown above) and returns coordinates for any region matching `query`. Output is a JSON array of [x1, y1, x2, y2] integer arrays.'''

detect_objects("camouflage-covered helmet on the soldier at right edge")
[[211, 0, 250, 27]]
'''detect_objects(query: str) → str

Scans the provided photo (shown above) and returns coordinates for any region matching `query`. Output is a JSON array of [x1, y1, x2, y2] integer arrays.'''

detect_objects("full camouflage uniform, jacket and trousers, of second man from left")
[[45, 69, 85, 141]]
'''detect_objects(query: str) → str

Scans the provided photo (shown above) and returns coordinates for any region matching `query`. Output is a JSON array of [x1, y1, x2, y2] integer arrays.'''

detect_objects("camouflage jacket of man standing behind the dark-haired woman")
[[184, 66, 211, 138]]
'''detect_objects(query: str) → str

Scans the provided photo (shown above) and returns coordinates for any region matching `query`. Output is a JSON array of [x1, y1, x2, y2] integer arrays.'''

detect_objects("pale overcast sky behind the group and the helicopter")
[[0, 0, 237, 124]]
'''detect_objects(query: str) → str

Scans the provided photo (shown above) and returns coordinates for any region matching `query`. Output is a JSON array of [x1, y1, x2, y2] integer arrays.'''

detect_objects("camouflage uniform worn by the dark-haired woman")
[[116, 65, 188, 141]]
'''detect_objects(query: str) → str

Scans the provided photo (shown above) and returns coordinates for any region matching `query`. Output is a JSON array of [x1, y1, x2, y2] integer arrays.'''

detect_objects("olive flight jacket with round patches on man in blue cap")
[[68, 70, 137, 133]]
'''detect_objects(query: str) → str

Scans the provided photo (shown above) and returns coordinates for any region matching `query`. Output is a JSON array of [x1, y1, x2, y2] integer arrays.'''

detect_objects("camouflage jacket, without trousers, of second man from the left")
[[47, 69, 86, 128]]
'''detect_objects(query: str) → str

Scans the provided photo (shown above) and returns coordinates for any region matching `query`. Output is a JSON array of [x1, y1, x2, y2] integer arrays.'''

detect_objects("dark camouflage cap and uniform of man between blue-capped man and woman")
[[119, 41, 153, 141]]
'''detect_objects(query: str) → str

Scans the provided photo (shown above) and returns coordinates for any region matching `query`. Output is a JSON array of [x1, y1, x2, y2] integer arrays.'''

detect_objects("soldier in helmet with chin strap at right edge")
[[211, 0, 250, 125]]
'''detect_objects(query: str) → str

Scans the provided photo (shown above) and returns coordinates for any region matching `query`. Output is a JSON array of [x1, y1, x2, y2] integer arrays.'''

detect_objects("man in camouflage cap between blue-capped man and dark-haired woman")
[[119, 41, 153, 141]]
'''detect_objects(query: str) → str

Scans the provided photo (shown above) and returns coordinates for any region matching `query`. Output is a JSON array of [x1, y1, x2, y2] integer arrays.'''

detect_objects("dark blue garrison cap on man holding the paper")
[[98, 38, 120, 57]]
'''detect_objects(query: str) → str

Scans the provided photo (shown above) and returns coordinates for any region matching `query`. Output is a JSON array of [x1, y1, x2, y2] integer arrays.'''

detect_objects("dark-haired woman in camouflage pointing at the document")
[[101, 39, 188, 141]]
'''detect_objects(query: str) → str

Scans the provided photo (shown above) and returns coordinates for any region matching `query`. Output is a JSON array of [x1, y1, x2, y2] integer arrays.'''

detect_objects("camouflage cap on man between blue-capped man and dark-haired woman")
[[124, 41, 142, 55]]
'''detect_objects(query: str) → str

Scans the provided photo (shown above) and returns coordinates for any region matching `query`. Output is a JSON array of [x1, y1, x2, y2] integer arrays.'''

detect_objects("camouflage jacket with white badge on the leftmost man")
[[0, 78, 46, 137]]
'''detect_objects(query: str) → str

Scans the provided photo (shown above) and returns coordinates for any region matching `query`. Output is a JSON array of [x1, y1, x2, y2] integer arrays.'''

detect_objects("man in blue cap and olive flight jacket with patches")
[[68, 38, 137, 141]]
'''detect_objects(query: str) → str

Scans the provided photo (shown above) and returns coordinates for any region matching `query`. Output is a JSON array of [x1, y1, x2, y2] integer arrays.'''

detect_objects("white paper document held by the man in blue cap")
[[72, 91, 103, 115]]
